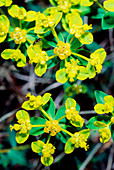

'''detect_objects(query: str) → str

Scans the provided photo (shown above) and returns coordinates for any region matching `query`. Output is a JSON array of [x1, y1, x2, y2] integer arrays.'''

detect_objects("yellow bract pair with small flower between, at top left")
[[8, 5, 37, 22]]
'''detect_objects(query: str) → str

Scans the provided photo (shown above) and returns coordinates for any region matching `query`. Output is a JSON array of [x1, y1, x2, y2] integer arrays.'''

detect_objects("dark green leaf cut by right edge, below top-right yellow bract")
[[102, 12, 114, 30]]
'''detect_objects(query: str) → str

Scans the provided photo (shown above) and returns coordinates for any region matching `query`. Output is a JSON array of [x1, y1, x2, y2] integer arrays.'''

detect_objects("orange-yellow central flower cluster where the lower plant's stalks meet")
[[44, 120, 61, 136]]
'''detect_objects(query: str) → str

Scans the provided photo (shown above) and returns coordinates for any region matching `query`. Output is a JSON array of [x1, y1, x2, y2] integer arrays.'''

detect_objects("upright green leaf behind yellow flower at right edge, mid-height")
[[95, 90, 108, 104]]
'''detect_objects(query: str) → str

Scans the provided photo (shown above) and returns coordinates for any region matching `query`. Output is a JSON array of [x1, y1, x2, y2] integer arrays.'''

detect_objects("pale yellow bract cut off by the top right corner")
[[103, 0, 114, 12]]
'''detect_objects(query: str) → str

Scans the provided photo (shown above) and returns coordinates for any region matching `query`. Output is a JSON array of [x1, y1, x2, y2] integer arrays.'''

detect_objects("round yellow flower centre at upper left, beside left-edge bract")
[[10, 27, 27, 44]]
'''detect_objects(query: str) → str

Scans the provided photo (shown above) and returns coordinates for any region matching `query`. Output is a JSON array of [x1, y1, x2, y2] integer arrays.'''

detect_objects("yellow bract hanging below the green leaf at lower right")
[[99, 127, 111, 143]]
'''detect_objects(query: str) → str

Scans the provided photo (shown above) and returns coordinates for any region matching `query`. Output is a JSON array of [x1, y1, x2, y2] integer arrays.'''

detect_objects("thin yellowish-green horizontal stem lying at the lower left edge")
[[0, 145, 30, 153]]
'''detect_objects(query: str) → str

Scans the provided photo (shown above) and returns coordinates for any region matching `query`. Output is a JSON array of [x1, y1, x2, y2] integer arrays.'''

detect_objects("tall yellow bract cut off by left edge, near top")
[[0, 15, 10, 43]]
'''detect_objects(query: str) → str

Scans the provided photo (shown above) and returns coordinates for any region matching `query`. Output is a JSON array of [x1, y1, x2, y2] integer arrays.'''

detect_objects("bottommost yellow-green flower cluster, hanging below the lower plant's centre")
[[31, 140, 56, 166]]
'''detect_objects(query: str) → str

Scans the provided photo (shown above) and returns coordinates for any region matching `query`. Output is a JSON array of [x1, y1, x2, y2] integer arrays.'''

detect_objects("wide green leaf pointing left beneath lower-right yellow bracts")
[[86, 115, 111, 130]]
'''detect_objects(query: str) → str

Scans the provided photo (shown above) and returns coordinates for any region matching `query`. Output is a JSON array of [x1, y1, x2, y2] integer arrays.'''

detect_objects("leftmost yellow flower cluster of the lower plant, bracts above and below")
[[10, 110, 32, 143]]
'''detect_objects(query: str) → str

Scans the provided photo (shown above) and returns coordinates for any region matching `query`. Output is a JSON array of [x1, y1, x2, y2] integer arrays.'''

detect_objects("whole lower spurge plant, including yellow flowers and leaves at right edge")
[[10, 91, 114, 166]]
